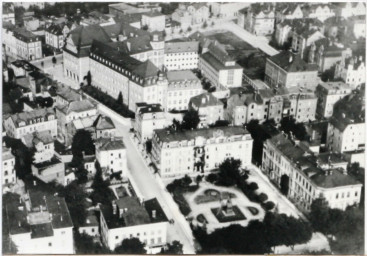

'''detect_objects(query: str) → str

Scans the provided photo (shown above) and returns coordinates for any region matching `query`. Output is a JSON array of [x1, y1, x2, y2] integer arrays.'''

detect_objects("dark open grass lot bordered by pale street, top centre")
[[206, 31, 259, 60]]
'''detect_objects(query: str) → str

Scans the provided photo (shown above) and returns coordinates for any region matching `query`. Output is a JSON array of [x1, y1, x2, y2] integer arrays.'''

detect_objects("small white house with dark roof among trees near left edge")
[[22, 131, 55, 164]]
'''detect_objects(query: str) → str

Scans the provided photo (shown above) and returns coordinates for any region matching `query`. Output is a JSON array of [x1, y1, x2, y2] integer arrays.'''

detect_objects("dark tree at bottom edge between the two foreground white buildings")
[[74, 230, 111, 254]]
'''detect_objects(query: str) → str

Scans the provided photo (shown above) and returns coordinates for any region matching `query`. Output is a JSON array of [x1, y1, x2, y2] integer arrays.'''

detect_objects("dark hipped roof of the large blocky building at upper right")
[[269, 51, 318, 72]]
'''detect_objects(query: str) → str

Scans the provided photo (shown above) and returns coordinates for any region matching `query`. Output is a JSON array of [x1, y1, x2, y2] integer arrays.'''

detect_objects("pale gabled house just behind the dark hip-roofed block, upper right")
[[308, 38, 352, 72]]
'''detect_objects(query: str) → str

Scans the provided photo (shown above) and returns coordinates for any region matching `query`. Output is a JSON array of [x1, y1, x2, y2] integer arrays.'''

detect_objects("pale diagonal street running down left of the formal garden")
[[101, 107, 195, 254]]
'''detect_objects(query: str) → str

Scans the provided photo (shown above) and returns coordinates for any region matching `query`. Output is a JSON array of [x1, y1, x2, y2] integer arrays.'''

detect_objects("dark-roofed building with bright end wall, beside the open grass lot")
[[198, 41, 243, 89]]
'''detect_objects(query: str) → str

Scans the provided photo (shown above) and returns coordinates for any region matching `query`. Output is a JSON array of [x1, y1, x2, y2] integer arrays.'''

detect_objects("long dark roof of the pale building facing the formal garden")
[[155, 126, 249, 142]]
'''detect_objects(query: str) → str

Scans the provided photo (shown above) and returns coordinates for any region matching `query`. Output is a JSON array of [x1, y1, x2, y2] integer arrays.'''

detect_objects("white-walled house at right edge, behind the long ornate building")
[[326, 115, 366, 153]]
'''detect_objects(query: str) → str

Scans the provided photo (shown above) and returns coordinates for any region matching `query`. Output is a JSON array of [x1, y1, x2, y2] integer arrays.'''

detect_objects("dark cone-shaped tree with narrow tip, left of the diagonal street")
[[90, 161, 115, 204]]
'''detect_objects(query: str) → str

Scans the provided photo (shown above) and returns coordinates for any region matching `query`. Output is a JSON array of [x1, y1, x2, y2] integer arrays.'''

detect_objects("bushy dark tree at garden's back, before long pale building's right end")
[[218, 158, 242, 186]]
